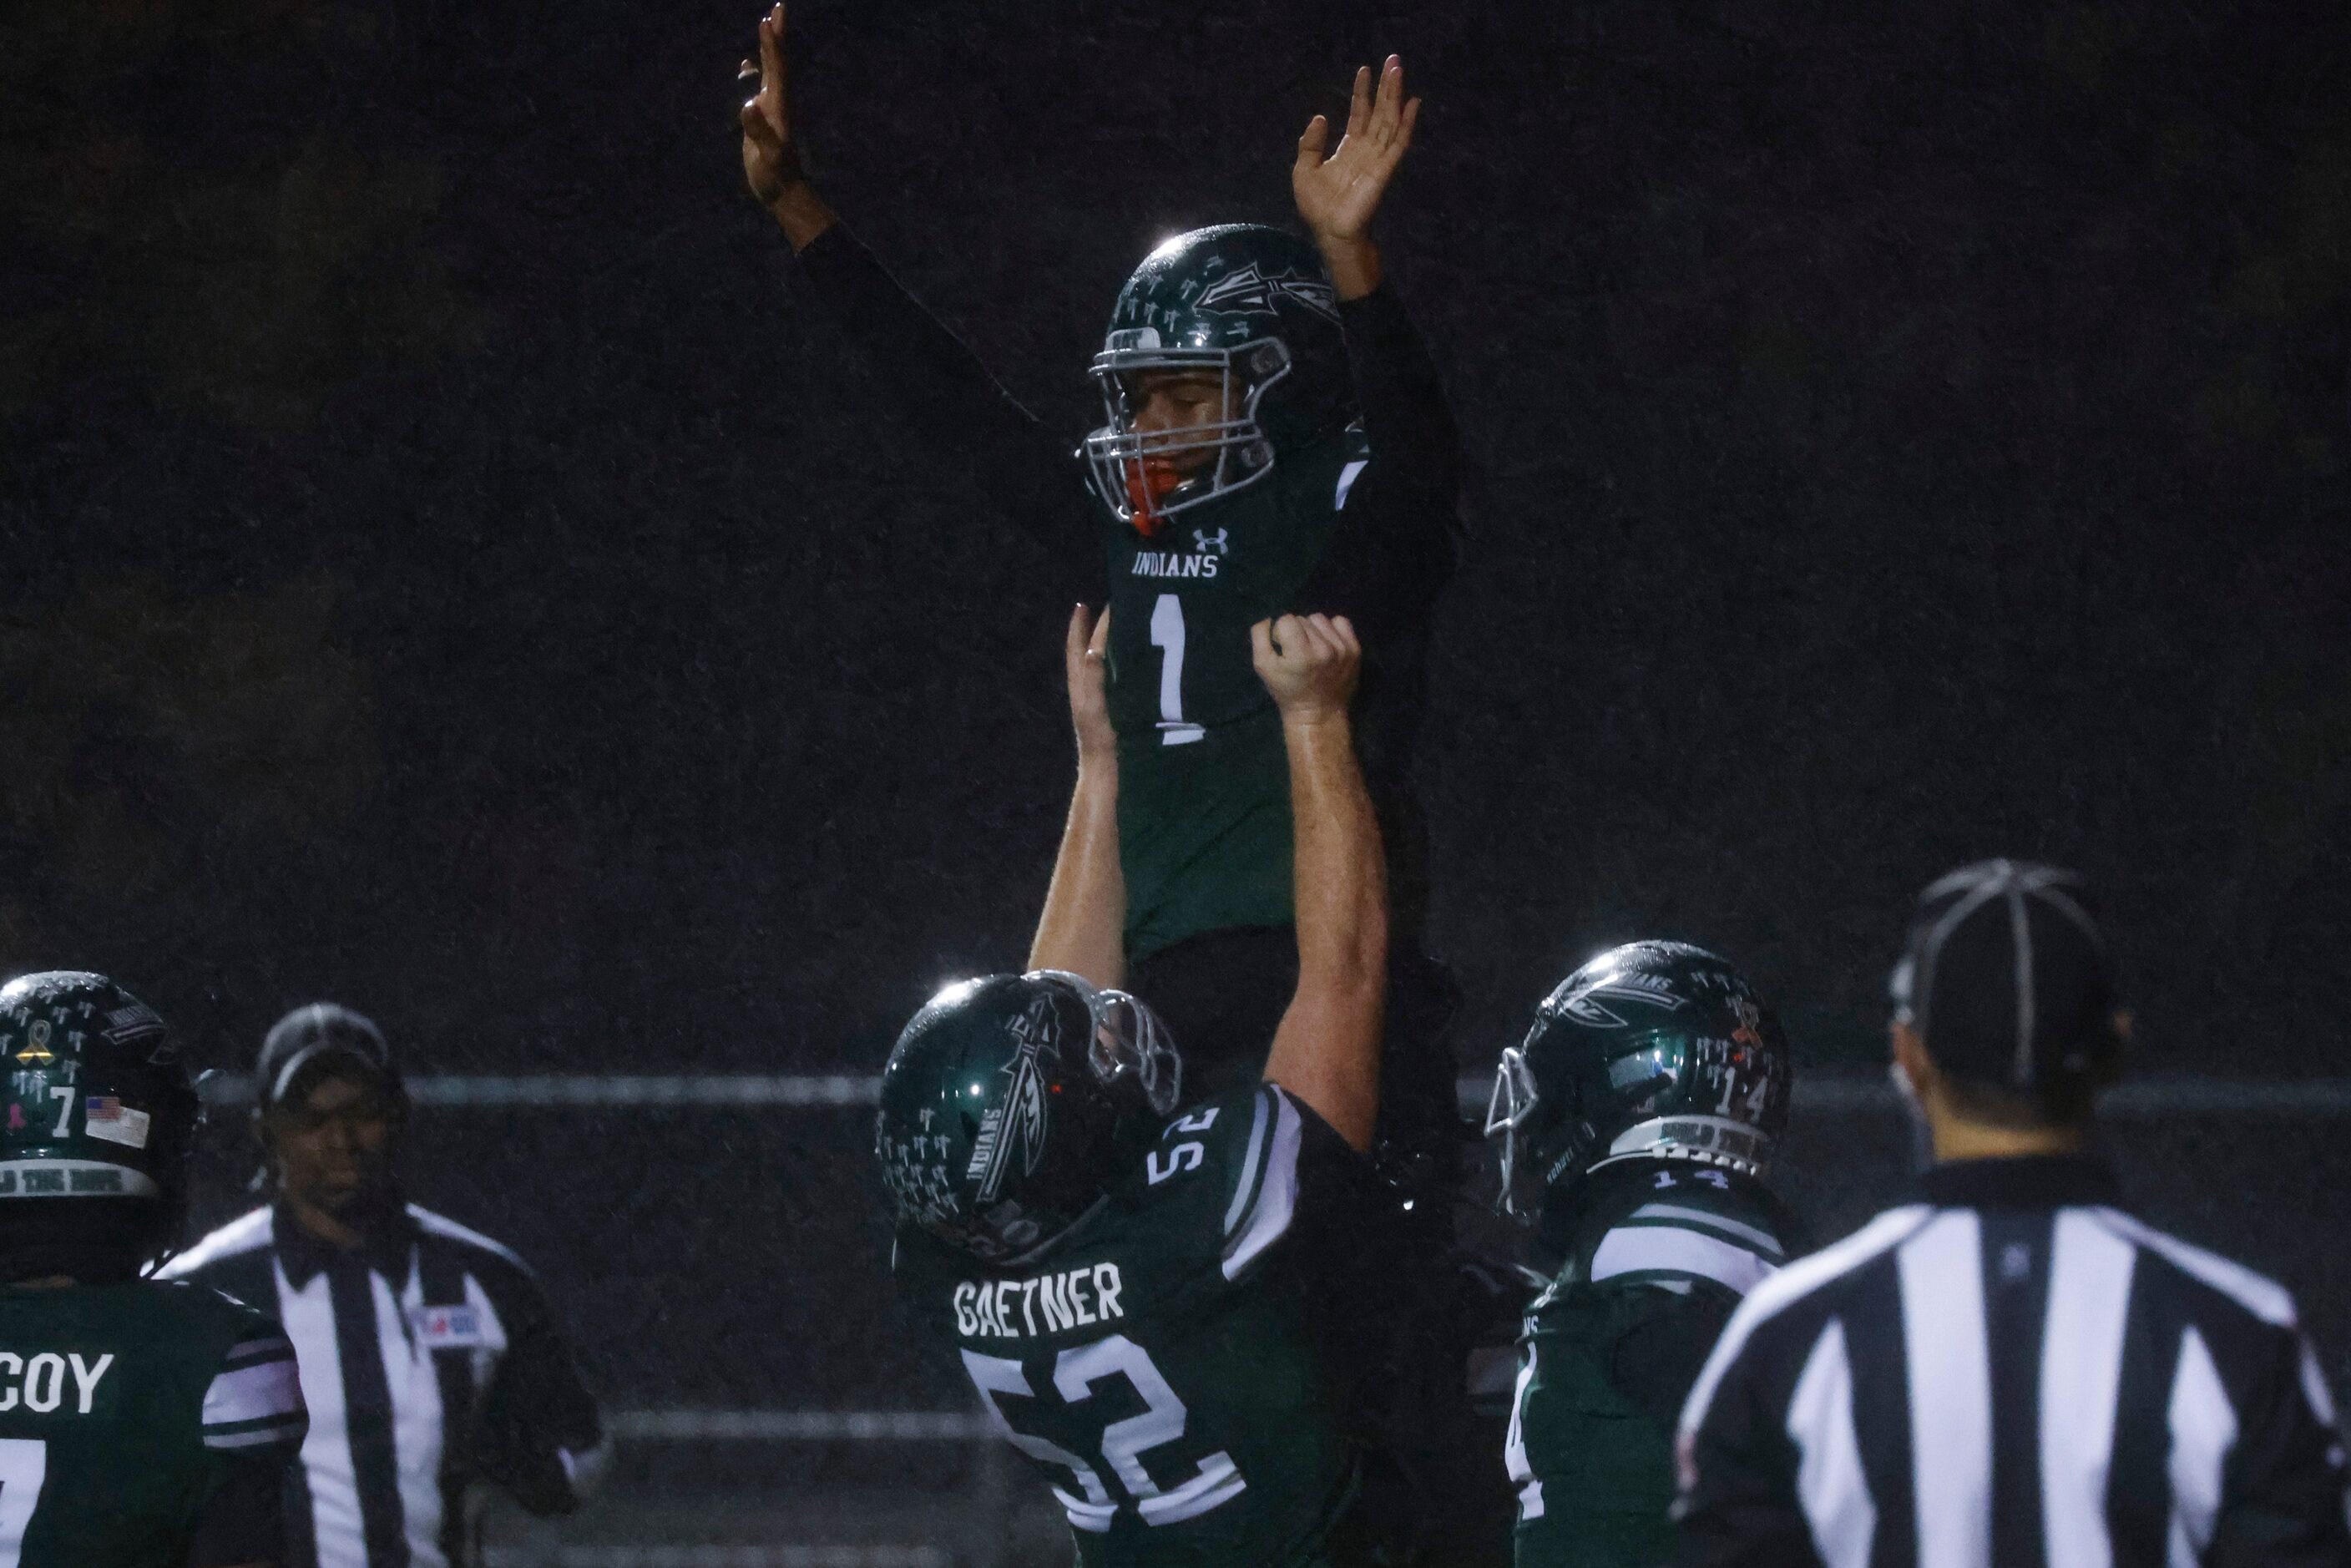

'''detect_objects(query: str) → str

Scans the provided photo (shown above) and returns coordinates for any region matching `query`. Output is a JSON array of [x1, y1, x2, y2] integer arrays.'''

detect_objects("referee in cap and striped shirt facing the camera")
[[164, 1004, 602, 1568]]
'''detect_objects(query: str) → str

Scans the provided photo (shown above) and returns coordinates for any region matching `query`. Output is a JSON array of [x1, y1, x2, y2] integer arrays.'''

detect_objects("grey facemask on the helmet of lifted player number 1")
[[1086, 326, 1291, 536]]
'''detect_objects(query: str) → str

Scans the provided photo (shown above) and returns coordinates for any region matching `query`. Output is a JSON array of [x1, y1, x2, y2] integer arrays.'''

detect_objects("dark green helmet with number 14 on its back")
[[1486, 943, 1789, 1217]]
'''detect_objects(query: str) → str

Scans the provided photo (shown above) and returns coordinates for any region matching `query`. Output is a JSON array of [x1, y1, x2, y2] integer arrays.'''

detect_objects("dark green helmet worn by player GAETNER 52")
[[875, 969, 1182, 1262]]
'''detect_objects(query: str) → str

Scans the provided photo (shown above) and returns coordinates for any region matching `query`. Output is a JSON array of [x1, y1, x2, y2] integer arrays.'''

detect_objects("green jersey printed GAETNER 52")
[[898, 1084, 1361, 1568]]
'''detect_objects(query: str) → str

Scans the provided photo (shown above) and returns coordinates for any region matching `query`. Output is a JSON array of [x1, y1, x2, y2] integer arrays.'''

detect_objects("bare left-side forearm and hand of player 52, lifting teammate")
[[1029, 604, 1126, 989]]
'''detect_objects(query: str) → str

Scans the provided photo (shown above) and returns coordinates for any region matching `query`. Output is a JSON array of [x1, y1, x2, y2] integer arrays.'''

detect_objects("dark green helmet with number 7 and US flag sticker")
[[0, 969, 202, 1256]]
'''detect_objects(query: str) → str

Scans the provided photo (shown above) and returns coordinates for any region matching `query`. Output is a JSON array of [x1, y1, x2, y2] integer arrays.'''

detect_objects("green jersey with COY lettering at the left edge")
[[0, 1279, 308, 1568]]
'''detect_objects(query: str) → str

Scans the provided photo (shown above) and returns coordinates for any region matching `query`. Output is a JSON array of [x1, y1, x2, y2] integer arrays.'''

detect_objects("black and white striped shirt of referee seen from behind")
[[1676, 1159, 2351, 1568]]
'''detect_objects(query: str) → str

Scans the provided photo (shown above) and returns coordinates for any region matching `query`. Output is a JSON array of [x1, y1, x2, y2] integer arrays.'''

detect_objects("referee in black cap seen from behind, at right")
[[1676, 861, 2351, 1568]]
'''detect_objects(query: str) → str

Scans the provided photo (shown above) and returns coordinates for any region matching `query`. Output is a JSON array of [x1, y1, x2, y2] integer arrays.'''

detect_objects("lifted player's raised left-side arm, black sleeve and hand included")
[[738, 5, 1100, 575]]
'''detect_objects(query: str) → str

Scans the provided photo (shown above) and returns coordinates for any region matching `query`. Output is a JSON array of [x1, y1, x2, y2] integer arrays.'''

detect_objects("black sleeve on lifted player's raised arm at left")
[[795, 223, 1100, 583]]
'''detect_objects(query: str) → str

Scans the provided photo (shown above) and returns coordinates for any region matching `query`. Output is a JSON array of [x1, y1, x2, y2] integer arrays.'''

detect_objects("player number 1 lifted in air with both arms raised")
[[741, 5, 1464, 1175]]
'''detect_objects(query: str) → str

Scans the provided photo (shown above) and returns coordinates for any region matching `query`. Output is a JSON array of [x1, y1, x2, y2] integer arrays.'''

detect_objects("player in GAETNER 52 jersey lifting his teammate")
[[875, 616, 1387, 1568]]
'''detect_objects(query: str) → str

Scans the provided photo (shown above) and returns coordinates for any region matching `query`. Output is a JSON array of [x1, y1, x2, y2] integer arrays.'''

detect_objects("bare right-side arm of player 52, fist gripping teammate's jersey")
[[1248, 616, 1387, 1150]]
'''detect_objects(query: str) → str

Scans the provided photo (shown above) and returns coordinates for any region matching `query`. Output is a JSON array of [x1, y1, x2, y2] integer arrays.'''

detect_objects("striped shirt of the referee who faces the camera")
[[164, 1204, 599, 1568]]
